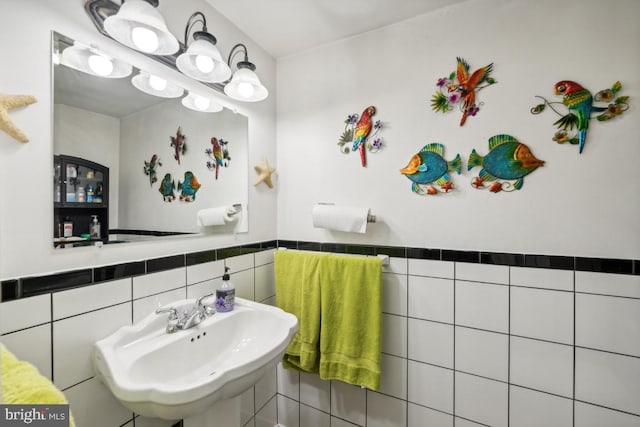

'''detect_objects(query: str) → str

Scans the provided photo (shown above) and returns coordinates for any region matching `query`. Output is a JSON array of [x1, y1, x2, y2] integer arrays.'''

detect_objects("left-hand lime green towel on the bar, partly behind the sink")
[[274, 251, 328, 372]]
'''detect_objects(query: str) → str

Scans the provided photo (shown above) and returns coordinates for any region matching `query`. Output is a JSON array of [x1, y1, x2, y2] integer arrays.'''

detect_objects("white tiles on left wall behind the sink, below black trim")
[[0, 250, 277, 427]]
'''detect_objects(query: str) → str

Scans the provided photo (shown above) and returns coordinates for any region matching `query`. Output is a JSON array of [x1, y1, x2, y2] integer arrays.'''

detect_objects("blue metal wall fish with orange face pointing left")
[[400, 143, 462, 194]]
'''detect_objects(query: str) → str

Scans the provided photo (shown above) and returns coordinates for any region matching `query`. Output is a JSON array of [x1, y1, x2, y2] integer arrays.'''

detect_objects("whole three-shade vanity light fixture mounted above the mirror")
[[84, 0, 269, 102]]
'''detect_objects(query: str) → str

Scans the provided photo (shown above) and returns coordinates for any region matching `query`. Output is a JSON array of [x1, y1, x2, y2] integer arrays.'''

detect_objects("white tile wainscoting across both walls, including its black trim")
[[0, 241, 640, 427]]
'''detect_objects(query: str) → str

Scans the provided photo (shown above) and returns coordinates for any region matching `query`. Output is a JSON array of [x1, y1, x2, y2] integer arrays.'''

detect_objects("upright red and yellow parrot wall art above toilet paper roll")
[[338, 105, 382, 167]]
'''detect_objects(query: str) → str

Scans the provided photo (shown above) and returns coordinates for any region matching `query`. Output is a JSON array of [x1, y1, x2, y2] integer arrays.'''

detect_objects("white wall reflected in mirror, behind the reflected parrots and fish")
[[119, 99, 249, 233]]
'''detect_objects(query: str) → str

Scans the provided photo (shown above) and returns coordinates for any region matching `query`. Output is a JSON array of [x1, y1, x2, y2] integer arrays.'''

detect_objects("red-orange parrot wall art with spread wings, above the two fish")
[[431, 57, 496, 126]]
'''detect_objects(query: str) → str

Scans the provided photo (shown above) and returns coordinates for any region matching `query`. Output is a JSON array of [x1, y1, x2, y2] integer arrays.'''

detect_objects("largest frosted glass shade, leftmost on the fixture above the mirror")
[[104, 0, 180, 55]]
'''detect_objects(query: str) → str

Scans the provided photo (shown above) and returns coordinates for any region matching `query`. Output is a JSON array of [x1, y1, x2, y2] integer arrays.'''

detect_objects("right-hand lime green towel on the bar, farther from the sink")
[[319, 255, 382, 390]]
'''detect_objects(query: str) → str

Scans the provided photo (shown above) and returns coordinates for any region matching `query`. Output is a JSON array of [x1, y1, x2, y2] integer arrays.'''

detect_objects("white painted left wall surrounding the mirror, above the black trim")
[[0, 0, 276, 279]]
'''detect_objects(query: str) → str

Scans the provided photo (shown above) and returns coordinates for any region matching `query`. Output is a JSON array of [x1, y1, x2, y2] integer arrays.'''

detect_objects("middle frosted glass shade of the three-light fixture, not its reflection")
[[176, 39, 231, 83]]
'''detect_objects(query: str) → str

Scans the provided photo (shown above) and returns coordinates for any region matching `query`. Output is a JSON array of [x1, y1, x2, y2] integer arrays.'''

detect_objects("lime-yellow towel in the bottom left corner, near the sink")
[[0, 344, 75, 427]]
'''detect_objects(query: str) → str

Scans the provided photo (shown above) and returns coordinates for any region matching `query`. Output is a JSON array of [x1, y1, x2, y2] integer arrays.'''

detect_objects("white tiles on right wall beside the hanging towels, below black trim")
[[278, 250, 640, 427]]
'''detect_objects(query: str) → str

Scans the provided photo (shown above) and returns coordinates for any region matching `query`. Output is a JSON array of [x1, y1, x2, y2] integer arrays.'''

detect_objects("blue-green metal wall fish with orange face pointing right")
[[467, 135, 544, 193]]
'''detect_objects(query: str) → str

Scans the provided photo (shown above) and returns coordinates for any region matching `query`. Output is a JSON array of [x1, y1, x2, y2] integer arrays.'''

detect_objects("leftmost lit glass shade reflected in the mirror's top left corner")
[[62, 42, 132, 79]]
